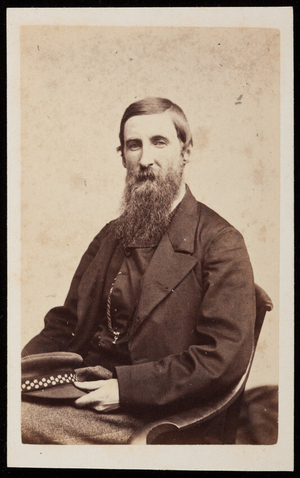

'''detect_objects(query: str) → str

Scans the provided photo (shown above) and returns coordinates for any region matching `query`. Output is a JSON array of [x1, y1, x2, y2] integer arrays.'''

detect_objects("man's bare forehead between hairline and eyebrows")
[[124, 111, 177, 140]]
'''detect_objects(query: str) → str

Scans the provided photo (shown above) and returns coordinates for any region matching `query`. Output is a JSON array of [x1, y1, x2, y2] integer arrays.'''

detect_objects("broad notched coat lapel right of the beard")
[[137, 187, 199, 323]]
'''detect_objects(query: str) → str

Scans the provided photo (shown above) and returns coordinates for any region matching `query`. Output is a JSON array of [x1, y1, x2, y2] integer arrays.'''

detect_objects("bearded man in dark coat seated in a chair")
[[22, 98, 255, 444]]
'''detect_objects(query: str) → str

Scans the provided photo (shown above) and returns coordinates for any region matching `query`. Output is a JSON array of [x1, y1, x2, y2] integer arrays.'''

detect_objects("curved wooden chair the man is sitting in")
[[130, 285, 273, 445]]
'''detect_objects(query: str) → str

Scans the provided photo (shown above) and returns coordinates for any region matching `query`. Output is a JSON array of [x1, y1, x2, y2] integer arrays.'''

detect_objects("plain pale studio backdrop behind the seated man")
[[21, 26, 280, 388]]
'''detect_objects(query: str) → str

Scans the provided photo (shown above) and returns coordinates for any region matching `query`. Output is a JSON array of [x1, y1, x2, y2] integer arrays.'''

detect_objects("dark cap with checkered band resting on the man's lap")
[[21, 352, 85, 399]]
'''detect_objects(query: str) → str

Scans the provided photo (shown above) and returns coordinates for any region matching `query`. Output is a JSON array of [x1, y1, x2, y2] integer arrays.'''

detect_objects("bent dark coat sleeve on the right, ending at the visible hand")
[[116, 227, 255, 408]]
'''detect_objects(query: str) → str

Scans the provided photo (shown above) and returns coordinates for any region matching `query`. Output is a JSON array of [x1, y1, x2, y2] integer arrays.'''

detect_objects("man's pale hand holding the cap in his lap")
[[74, 378, 120, 412]]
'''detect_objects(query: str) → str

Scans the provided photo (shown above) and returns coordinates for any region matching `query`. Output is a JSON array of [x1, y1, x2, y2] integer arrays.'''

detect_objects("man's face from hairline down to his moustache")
[[123, 112, 183, 184]]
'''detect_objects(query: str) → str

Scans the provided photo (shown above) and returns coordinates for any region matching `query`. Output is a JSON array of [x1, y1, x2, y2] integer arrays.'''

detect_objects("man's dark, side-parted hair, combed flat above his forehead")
[[117, 97, 193, 154]]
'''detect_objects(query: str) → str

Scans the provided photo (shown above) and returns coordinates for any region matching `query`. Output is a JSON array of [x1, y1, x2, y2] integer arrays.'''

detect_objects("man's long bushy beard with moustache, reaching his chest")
[[116, 166, 183, 247]]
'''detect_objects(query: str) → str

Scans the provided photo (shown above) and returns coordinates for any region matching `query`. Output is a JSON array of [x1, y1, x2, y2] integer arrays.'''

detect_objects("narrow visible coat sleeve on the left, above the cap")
[[22, 228, 106, 357]]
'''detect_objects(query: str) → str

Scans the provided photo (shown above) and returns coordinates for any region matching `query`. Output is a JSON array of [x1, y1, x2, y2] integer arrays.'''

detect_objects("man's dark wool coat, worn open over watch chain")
[[23, 188, 255, 410]]
